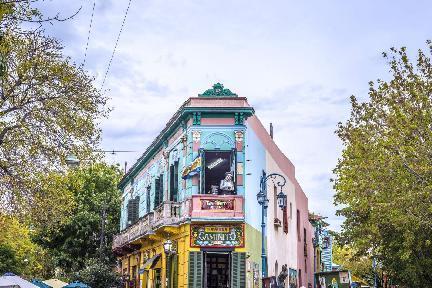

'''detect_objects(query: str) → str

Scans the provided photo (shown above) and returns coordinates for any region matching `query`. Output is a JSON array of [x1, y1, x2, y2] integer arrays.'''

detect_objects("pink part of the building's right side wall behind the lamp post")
[[247, 116, 313, 287]]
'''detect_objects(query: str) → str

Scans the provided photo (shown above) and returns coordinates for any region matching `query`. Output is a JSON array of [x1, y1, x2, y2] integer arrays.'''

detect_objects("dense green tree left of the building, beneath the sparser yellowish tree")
[[34, 163, 122, 275]]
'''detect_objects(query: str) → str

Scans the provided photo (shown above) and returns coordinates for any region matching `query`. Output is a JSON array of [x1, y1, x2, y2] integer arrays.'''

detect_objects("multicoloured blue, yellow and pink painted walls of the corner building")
[[120, 98, 313, 288]]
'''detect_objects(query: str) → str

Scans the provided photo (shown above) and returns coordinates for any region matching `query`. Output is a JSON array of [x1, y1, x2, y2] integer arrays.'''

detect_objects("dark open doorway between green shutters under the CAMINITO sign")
[[204, 252, 231, 288]]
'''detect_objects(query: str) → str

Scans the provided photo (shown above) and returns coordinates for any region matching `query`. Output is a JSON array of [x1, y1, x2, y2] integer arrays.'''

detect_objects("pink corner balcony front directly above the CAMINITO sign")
[[190, 195, 244, 222]]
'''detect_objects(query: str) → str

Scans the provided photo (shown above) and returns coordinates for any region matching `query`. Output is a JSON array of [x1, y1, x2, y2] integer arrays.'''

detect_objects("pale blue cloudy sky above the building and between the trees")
[[39, 0, 432, 230]]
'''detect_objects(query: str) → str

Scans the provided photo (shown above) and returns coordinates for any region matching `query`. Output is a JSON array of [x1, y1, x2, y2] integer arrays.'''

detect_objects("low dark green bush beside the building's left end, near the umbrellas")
[[74, 258, 121, 288]]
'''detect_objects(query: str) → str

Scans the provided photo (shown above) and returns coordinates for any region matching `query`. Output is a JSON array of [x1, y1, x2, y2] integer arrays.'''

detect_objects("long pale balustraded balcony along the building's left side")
[[112, 201, 190, 250]]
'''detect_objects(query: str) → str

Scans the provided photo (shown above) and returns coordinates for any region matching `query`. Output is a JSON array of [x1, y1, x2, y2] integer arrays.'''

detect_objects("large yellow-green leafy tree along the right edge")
[[334, 41, 432, 288]]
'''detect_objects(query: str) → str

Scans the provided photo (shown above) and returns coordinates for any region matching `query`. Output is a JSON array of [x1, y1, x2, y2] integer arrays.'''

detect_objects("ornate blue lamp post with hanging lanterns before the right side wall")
[[257, 171, 287, 278]]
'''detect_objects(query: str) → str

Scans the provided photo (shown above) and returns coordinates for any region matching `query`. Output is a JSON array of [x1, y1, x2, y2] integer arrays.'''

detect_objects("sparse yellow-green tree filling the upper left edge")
[[0, 1, 107, 211]]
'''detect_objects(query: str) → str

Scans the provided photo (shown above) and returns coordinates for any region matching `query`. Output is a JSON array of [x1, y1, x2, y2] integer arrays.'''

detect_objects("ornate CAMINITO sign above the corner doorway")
[[190, 224, 244, 247]]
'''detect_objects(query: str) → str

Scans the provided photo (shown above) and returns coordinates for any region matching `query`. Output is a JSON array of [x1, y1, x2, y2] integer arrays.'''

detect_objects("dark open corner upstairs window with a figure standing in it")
[[202, 150, 236, 195]]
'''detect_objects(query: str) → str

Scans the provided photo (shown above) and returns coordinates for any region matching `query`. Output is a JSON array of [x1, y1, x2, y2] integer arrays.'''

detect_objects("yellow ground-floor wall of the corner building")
[[120, 224, 261, 288]]
